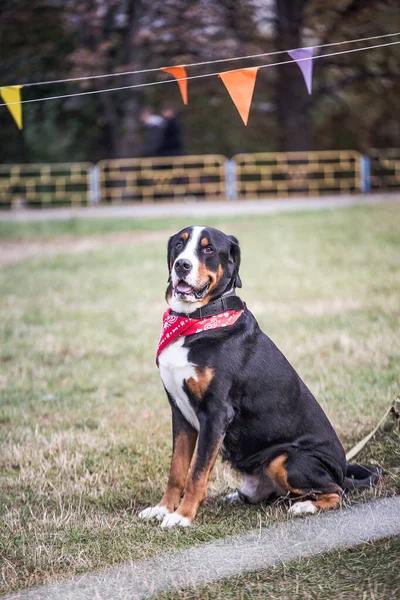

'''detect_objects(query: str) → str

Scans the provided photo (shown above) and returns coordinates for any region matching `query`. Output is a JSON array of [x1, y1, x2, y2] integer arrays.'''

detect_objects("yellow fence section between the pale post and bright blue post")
[[233, 151, 361, 199]]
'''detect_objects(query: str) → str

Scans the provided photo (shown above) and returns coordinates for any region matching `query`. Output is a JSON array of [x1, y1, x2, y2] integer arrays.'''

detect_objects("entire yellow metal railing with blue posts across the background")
[[0, 149, 400, 208]]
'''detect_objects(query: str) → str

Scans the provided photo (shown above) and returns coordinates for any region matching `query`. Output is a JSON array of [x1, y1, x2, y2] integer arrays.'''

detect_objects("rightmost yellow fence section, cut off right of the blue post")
[[369, 148, 400, 190]]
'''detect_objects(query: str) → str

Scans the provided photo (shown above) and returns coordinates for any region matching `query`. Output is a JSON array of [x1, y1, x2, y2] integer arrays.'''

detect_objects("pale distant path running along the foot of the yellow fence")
[[0, 193, 400, 221]]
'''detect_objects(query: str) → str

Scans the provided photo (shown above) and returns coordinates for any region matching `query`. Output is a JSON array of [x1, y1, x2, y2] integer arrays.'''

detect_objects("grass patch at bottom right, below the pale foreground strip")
[[153, 537, 400, 600]]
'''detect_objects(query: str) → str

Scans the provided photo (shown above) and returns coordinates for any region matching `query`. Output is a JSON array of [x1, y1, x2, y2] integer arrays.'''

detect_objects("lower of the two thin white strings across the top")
[[0, 39, 400, 106]]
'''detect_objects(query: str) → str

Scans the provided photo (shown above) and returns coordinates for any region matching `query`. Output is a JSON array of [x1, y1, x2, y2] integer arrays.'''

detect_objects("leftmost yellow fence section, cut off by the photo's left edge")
[[0, 163, 91, 208]]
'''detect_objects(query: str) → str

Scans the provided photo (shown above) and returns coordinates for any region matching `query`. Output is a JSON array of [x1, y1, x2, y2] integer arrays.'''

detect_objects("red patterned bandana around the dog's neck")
[[156, 308, 243, 364]]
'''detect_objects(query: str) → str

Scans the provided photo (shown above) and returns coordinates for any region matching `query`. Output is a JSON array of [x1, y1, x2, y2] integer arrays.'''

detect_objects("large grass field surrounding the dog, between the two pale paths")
[[0, 205, 400, 598]]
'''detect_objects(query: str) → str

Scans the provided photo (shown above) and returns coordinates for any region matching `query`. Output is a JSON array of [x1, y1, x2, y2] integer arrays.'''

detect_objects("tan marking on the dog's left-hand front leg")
[[159, 431, 197, 512]]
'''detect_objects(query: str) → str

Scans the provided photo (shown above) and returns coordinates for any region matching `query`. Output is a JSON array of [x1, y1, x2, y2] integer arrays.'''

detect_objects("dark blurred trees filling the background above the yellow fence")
[[0, 0, 400, 162]]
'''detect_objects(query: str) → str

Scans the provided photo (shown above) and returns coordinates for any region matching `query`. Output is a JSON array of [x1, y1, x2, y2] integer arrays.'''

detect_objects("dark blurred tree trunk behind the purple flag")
[[276, 0, 310, 152]]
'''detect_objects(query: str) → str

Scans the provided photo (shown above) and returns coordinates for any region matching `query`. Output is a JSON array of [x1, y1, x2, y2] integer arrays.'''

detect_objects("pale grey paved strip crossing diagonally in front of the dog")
[[4, 496, 400, 600]]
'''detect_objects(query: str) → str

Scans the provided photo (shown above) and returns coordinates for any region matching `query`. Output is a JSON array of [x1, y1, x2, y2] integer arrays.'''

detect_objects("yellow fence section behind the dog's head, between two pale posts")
[[98, 154, 226, 203]]
